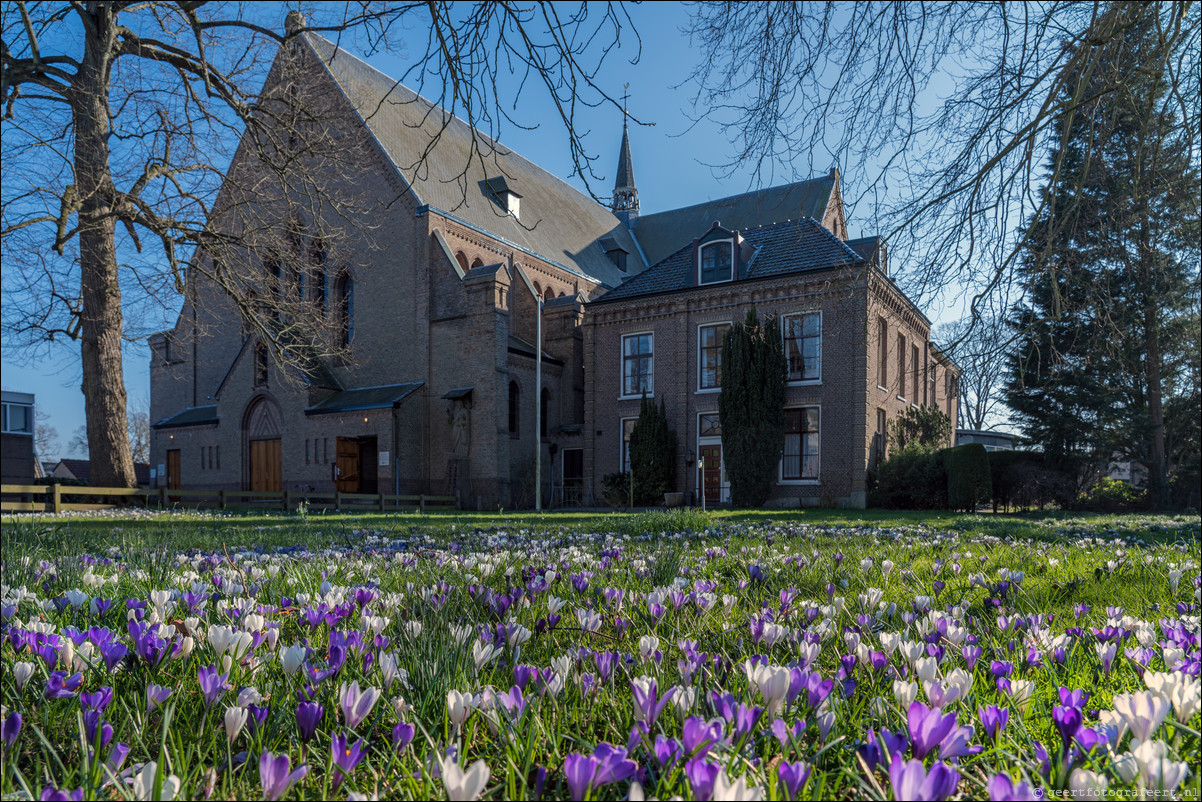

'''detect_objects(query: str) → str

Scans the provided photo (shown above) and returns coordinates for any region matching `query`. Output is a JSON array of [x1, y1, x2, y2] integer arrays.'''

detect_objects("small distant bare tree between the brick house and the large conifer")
[[936, 315, 1014, 429]]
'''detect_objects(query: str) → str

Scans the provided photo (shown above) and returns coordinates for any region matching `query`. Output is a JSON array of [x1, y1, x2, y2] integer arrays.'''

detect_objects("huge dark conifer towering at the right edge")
[[1007, 29, 1202, 506]]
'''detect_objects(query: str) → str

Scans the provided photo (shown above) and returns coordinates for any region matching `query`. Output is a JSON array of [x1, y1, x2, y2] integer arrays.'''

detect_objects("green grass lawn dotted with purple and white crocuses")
[[0, 510, 1200, 798]]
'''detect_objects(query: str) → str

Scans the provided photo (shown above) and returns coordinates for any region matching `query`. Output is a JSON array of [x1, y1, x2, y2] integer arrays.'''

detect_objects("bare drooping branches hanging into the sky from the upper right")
[[689, 0, 1202, 317]]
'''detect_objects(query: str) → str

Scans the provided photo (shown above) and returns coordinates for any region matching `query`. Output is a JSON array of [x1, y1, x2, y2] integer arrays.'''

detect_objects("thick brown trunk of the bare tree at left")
[[72, 4, 137, 487]]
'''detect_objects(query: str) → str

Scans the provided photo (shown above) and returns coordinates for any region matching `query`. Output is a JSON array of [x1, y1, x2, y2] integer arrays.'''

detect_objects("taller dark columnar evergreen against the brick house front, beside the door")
[[718, 309, 789, 506]]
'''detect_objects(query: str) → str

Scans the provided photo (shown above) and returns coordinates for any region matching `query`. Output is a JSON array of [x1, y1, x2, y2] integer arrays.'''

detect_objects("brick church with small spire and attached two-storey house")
[[150, 34, 957, 509]]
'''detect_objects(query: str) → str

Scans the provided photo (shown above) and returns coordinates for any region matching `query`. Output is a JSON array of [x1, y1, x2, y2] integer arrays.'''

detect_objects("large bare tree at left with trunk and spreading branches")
[[0, 1, 629, 486]]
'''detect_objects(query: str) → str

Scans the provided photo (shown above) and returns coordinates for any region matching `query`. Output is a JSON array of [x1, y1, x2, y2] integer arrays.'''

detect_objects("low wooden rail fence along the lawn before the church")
[[0, 485, 456, 512]]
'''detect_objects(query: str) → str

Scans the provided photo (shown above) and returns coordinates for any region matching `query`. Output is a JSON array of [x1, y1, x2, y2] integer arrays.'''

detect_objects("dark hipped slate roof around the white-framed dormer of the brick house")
[[590, 218, 863, 304]]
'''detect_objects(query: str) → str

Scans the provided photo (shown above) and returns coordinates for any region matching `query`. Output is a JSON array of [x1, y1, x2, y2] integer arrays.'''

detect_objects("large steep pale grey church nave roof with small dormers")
[[304, 34, 645, 287]]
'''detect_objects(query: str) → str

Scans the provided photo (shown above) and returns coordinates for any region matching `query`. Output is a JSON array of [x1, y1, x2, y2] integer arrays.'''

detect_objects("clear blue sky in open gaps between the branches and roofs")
[[0, 2, 957, 458]]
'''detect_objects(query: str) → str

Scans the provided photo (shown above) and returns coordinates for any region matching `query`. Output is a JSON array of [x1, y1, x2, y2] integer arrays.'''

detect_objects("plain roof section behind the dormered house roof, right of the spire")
[[635, 171, 834, 265]]
